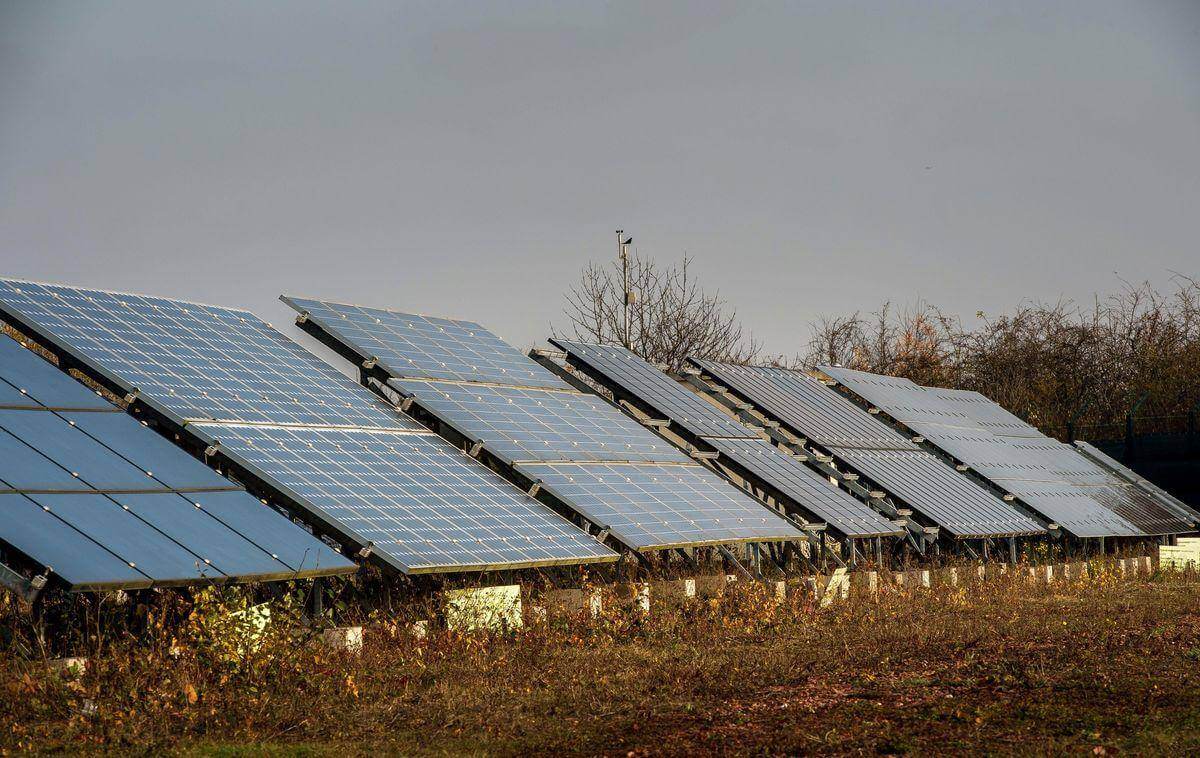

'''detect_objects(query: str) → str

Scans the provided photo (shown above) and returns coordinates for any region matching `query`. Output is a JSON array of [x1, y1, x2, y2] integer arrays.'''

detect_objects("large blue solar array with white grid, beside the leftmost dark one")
[[0, 281, 617, 572]]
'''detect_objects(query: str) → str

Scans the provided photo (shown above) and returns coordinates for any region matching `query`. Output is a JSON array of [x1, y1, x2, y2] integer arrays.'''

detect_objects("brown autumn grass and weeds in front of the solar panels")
[[0, 566, 1200, 756]]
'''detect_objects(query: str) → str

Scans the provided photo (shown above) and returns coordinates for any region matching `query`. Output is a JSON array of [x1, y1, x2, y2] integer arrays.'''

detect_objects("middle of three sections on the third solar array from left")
[[389, 379, 688, 463]]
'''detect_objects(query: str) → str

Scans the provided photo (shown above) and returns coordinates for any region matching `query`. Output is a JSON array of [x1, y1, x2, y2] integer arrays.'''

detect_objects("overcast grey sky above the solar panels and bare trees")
[[0, 0, 1200, 362]]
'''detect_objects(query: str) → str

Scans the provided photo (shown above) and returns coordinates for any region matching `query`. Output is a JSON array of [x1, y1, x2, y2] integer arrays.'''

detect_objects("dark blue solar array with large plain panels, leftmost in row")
[[0, 336, 355, 590]]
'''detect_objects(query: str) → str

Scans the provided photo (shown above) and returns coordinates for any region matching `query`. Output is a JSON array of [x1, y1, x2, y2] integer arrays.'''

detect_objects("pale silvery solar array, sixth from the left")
[[820, 366, 1145, 537]]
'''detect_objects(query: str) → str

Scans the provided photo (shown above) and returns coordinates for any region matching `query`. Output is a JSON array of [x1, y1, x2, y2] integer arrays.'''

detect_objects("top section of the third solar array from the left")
[[280, 295, 570, 390]]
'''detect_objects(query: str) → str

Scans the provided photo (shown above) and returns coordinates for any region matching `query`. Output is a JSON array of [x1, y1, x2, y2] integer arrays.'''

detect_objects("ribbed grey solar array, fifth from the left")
[[692, 360, 1045, 537]]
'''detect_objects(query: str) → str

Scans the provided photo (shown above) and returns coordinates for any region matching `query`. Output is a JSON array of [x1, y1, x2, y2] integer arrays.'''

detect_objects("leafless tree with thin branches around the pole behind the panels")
[[553, 253, 760, 371]]
